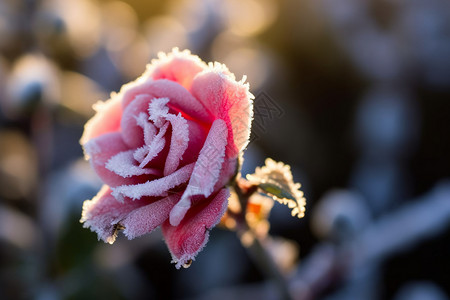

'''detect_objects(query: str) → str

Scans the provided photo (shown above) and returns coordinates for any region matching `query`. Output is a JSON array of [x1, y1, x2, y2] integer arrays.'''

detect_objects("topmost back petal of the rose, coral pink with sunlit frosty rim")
[[144, 48, 207, 90]]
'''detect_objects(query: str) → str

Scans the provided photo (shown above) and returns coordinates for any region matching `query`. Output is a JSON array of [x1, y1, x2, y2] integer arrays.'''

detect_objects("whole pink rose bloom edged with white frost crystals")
[[80, 49, 253, 268]]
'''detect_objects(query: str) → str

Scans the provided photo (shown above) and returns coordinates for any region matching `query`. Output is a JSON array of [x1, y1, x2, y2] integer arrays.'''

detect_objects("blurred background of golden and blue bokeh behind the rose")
[[0, 0, 450, 300]]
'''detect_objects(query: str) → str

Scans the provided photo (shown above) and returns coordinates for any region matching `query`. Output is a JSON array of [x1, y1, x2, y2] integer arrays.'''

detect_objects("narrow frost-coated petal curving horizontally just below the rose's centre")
[[112, 163, 194, 201]]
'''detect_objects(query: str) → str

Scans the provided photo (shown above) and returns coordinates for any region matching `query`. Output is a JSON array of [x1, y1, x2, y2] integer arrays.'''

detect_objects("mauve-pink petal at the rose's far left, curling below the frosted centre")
[[84, 132, 141, 187]]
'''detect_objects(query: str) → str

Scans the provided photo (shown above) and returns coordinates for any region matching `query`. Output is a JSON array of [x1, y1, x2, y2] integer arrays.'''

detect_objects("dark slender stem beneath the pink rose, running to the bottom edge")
[[233, 180, 292, 300]]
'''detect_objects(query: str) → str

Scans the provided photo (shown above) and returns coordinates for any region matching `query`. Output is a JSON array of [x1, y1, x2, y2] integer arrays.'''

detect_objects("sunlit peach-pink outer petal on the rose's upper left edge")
[[80, 94, 122, 145]]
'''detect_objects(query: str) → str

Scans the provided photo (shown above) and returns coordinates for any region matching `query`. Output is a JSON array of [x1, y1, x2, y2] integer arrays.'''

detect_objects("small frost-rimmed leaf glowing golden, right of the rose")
[[247, 158, 306, 218]]
